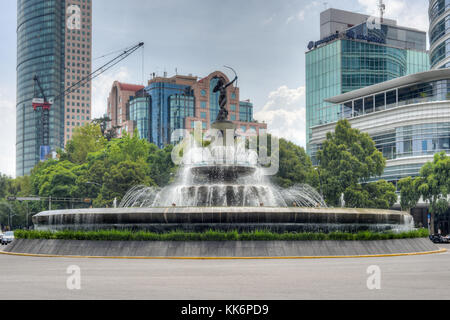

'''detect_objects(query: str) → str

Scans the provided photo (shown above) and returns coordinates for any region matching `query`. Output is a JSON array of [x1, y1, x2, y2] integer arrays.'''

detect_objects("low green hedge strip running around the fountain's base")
[[15, 229, 429, 241]]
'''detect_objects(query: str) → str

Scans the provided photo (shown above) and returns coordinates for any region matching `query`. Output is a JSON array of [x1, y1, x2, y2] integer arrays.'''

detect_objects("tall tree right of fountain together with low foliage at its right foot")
[[317, 120, 390, 209]]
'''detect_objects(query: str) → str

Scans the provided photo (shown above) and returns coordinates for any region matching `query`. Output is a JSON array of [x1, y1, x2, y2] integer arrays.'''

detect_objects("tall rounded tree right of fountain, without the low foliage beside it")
[[317, 120, 386, 206]]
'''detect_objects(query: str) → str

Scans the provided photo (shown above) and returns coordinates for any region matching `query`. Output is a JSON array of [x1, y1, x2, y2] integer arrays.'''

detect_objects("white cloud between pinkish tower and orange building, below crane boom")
[[92, 67, 131, 119]]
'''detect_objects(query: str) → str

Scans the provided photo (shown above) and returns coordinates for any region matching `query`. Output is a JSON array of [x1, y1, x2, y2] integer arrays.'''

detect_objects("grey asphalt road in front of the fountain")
[[0, 245, 450, 300]]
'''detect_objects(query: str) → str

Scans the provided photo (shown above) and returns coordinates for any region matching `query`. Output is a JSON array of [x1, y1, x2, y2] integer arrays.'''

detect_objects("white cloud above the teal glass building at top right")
[[358, 0, 429, 31]]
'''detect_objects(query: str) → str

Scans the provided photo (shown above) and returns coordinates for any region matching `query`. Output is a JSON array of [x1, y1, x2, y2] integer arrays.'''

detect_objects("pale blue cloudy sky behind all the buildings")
[[0, 0, 428, 176]]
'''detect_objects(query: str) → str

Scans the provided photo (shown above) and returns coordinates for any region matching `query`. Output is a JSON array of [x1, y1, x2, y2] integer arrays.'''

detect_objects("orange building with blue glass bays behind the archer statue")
[[107, 71, 267, 148]]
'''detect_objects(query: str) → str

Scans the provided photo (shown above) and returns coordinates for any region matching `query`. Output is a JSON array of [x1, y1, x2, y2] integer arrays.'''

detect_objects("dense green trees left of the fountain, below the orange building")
[[26, 125, 167, 210]]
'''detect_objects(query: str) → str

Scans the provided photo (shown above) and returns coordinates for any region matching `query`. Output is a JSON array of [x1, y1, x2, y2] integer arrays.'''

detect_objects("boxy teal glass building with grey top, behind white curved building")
[[306, 9, 429, 155]]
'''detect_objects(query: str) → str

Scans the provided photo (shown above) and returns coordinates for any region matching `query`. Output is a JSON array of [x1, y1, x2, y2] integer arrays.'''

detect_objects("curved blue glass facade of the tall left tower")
[[16, 0, 65, 176]]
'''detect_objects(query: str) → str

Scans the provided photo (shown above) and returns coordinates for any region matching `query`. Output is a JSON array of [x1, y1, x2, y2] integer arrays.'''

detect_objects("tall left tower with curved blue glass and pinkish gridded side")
[[16, 0, 92, 176]]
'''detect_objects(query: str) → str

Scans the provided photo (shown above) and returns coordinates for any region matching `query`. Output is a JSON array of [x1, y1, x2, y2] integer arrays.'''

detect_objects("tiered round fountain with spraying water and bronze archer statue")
[[33, 71, 413, 232]]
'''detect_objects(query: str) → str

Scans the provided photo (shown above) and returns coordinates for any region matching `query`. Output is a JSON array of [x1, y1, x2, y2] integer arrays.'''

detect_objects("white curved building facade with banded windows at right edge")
[[311, 70, 450, 183]]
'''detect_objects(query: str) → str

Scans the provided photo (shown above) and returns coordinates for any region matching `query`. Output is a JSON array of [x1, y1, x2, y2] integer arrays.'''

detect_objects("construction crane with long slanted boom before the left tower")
[[32, 42, 144, 161]]
